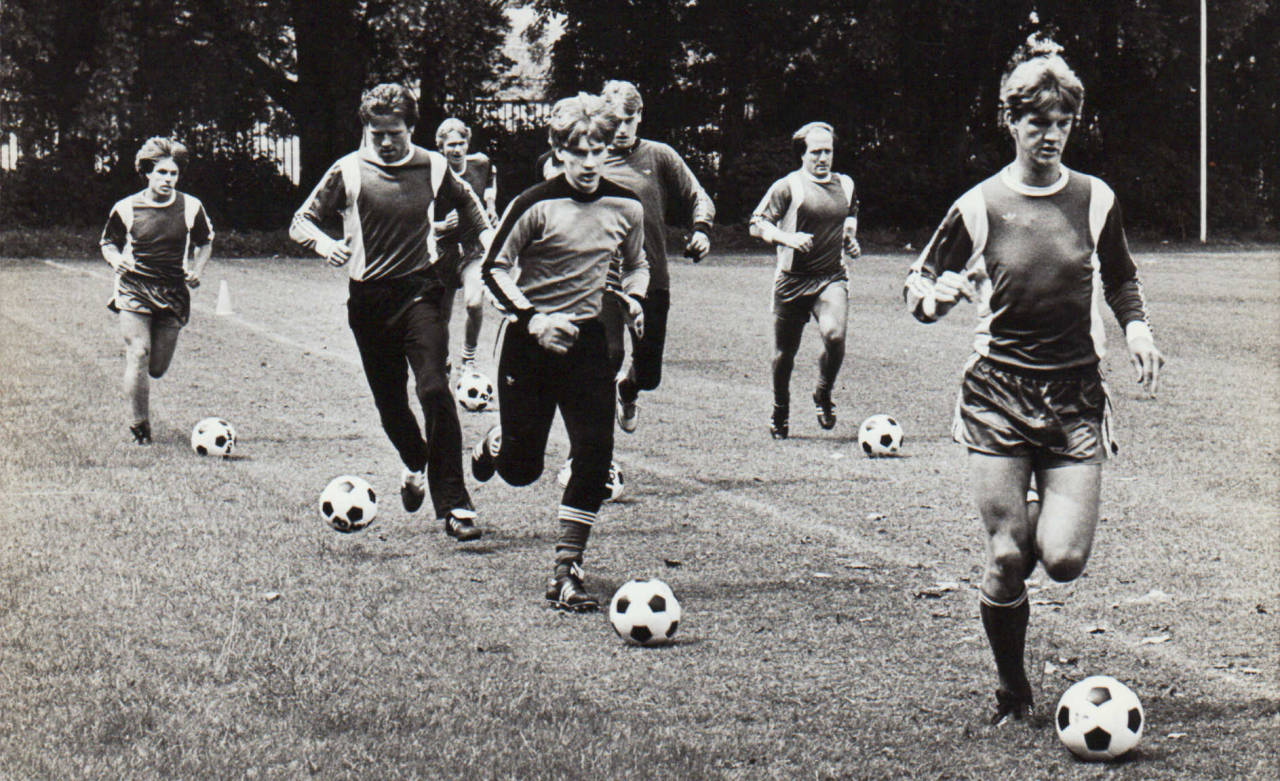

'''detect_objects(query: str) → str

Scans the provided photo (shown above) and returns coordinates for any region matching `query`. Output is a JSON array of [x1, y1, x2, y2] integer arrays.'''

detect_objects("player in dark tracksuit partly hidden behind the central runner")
[[602, 81, 716, 433]]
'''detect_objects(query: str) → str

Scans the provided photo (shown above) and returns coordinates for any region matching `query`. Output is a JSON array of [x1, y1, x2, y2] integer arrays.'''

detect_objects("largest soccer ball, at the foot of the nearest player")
[[1055, 675, 1146, 761]]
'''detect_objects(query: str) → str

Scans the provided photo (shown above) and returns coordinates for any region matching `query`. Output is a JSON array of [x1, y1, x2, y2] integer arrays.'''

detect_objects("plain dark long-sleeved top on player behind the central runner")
[[600, 138, 716, 291]]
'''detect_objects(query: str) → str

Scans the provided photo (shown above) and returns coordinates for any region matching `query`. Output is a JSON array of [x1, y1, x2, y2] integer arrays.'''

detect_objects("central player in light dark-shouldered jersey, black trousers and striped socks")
[[471, 93, 649, 612]]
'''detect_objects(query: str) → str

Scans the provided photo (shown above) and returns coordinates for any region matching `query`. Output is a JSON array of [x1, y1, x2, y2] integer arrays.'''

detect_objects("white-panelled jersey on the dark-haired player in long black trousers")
[[289, 146, 489, 282]]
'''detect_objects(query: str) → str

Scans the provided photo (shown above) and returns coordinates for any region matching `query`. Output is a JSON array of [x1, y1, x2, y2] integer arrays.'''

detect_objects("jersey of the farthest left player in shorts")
[[99, 189, 214, 284]]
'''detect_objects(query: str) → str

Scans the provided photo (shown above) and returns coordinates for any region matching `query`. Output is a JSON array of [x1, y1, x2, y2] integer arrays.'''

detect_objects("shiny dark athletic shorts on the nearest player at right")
[[951, 356, 1119, 466]]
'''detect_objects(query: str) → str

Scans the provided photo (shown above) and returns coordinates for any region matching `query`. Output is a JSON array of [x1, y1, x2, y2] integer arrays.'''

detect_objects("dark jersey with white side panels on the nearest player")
[[904, 168, 1147, 369]]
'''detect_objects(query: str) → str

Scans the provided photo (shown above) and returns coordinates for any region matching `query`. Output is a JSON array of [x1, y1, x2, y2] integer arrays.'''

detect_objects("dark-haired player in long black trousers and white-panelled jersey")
[[289, 83, 492, 542]]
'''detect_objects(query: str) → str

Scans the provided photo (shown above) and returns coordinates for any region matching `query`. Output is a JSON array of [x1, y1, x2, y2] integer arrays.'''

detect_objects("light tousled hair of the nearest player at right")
[[1000, 33, 1084, 127]]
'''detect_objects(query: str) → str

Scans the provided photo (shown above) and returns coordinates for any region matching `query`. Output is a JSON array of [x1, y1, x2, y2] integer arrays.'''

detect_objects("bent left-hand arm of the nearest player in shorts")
[[902, 206, 978, 323]]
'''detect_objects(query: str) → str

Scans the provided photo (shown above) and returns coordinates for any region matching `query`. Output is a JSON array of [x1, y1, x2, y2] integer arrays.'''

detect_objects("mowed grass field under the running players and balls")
[[0, 252, 1280, 778]]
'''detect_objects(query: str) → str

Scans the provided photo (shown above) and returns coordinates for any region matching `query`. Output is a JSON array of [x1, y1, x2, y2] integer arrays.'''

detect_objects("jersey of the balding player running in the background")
[[751, 169, 858, 277]]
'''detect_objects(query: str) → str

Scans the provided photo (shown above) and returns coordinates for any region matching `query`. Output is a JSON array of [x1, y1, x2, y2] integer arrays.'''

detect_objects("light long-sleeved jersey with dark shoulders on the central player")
[[481, 175, 649, 326]]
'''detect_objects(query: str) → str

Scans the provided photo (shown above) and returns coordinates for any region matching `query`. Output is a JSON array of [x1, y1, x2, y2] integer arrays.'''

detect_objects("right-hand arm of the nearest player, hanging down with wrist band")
[[1097, 192, 1165, 394]]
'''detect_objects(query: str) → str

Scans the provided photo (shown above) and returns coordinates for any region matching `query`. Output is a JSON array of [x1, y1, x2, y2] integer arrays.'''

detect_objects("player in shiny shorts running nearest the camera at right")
[[904, 36, 1165, 723]]
